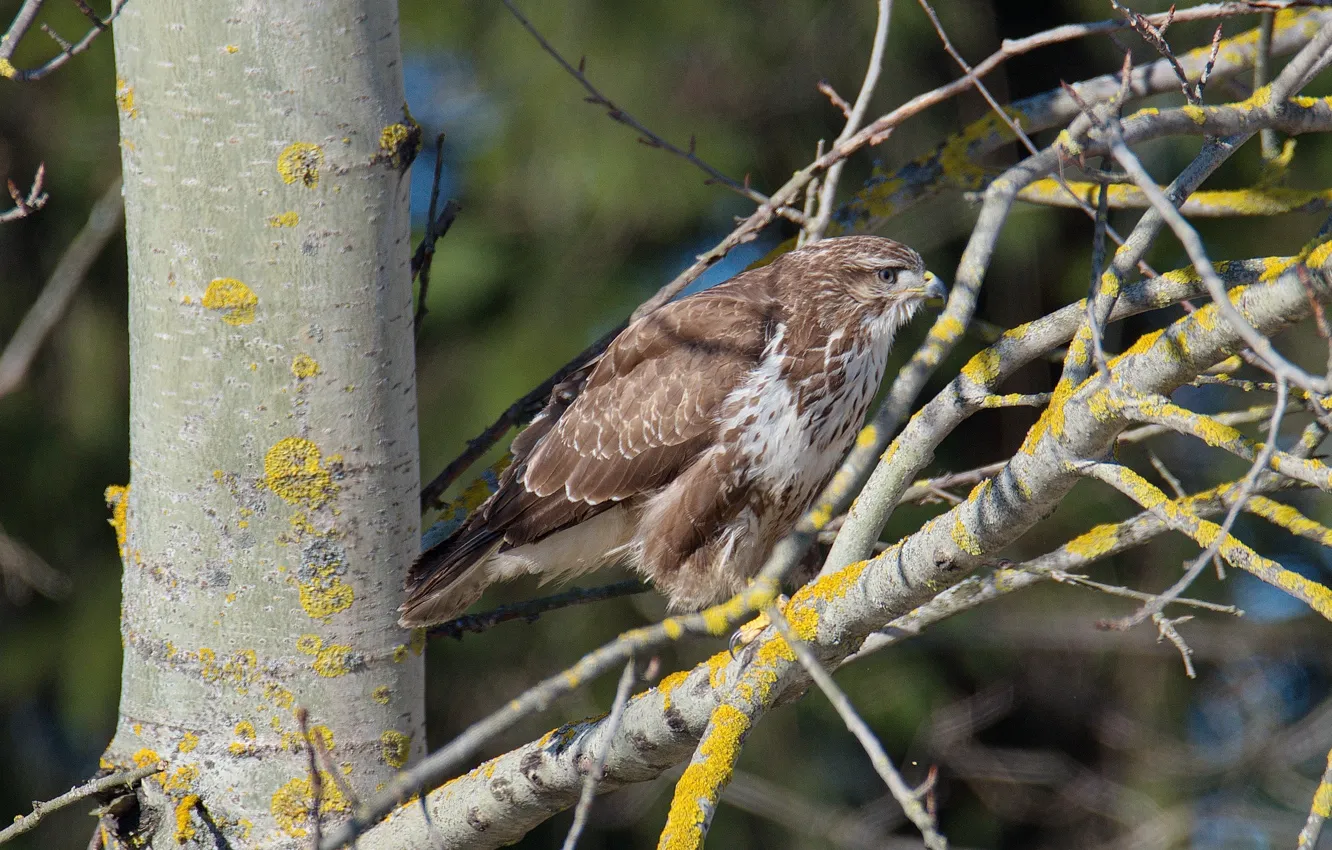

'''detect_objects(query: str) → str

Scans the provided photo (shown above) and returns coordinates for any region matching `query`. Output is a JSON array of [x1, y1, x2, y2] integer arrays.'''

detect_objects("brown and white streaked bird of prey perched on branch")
[[400, 236, 946, 626]]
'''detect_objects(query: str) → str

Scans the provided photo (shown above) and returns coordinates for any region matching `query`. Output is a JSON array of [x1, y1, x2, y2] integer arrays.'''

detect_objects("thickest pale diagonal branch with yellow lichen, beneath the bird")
[[325, 250, 1332, 847]]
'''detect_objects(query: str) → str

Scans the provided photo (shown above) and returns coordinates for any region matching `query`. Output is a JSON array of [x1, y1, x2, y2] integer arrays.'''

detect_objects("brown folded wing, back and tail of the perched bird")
[[402, 289, 779, 621]]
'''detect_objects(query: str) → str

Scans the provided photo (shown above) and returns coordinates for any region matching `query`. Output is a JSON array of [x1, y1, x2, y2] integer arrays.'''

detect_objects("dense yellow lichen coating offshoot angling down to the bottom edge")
[[657, 703, 750, 850]]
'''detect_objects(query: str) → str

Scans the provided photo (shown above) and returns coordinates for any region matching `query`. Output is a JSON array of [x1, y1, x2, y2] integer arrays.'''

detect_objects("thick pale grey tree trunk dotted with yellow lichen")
[[107, 0, 425, 847]]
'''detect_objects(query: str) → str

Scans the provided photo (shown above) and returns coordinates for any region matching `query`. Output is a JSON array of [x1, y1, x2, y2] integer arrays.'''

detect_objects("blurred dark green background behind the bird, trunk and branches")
[[0, 0, 1332, 849]]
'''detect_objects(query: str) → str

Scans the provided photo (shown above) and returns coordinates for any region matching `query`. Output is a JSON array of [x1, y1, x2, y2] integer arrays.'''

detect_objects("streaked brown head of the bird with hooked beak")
[[774, 236, 948, 336]]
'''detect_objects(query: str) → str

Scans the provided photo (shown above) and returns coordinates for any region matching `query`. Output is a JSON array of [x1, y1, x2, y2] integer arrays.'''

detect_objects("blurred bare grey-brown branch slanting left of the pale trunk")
[[0, 177, 125, 397]]
